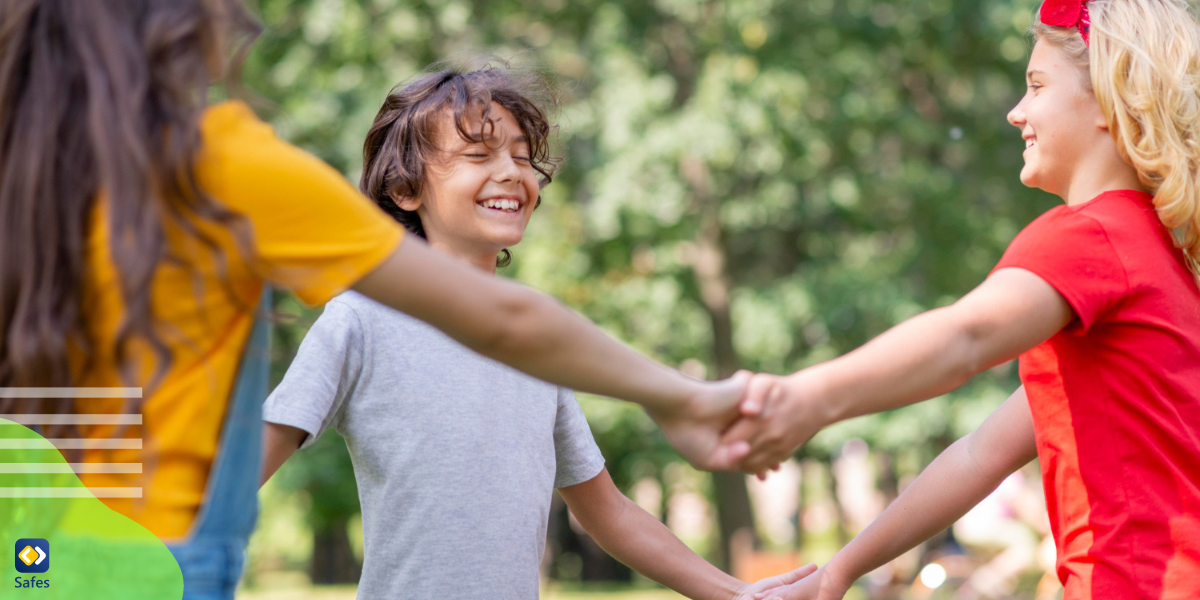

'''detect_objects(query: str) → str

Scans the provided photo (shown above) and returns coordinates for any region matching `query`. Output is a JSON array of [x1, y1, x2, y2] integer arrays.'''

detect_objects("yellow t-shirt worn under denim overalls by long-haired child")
[[78, 102, 403, 540]]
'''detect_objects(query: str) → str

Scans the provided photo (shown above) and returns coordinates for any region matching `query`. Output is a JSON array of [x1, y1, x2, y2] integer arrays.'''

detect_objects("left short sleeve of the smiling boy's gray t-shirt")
[[263, 299, 364, 448]]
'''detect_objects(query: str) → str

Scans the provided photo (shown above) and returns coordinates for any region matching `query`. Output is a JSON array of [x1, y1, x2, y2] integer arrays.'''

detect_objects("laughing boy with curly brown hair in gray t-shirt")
[[264, 67, 815, 600]]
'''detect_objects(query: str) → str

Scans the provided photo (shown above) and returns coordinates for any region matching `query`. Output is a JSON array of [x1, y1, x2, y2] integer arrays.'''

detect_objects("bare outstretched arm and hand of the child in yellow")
[[354, 235, 746, 469]]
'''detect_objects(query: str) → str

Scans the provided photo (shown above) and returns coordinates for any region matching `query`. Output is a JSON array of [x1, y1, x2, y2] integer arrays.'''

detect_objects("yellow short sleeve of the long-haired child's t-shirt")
[[196, 102, 403, 306]]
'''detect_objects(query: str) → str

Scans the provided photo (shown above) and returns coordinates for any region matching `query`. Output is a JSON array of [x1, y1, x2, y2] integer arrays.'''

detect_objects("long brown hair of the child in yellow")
[[0, 0, 258, 410]]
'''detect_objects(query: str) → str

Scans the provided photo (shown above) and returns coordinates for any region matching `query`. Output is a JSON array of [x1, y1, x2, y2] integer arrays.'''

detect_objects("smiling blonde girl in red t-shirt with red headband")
[[731, 0, 1200, 600]]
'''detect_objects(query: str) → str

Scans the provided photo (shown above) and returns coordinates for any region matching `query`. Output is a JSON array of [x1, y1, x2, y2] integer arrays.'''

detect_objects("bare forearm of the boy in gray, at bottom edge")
[[581, 499, 742, 600]]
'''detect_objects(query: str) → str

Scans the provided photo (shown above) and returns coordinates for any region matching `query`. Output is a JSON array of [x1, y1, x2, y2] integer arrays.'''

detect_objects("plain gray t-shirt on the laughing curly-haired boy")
[[263, 292, 604, 600]]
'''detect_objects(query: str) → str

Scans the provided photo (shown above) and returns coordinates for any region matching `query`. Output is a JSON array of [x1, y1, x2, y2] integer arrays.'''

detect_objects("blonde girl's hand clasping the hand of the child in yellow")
[[721, 371, 833, 476]]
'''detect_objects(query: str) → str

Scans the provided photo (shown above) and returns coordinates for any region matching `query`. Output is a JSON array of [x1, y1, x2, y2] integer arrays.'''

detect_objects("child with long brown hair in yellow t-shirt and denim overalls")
[[0, 0, 744, 598]]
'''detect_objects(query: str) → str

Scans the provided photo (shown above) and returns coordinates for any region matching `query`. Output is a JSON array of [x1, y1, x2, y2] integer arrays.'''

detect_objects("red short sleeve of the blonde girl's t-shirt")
[[992, 206, 1129, 332]]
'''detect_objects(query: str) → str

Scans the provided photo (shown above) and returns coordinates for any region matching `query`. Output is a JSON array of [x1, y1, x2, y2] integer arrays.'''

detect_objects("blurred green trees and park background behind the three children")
[[239, 0, 1061, 600]]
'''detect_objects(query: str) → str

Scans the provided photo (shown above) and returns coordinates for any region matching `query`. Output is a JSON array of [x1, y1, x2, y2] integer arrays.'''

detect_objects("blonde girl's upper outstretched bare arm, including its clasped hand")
[[725, 269, 1075, 473]]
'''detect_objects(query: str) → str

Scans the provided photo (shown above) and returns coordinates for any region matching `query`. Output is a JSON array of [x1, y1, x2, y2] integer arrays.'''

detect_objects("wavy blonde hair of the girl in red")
[[1033, 0, 1200, 274]]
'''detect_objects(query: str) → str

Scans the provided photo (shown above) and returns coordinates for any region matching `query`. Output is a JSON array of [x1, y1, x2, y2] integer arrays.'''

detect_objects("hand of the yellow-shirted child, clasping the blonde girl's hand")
[[647, 371, 750, 470]]
